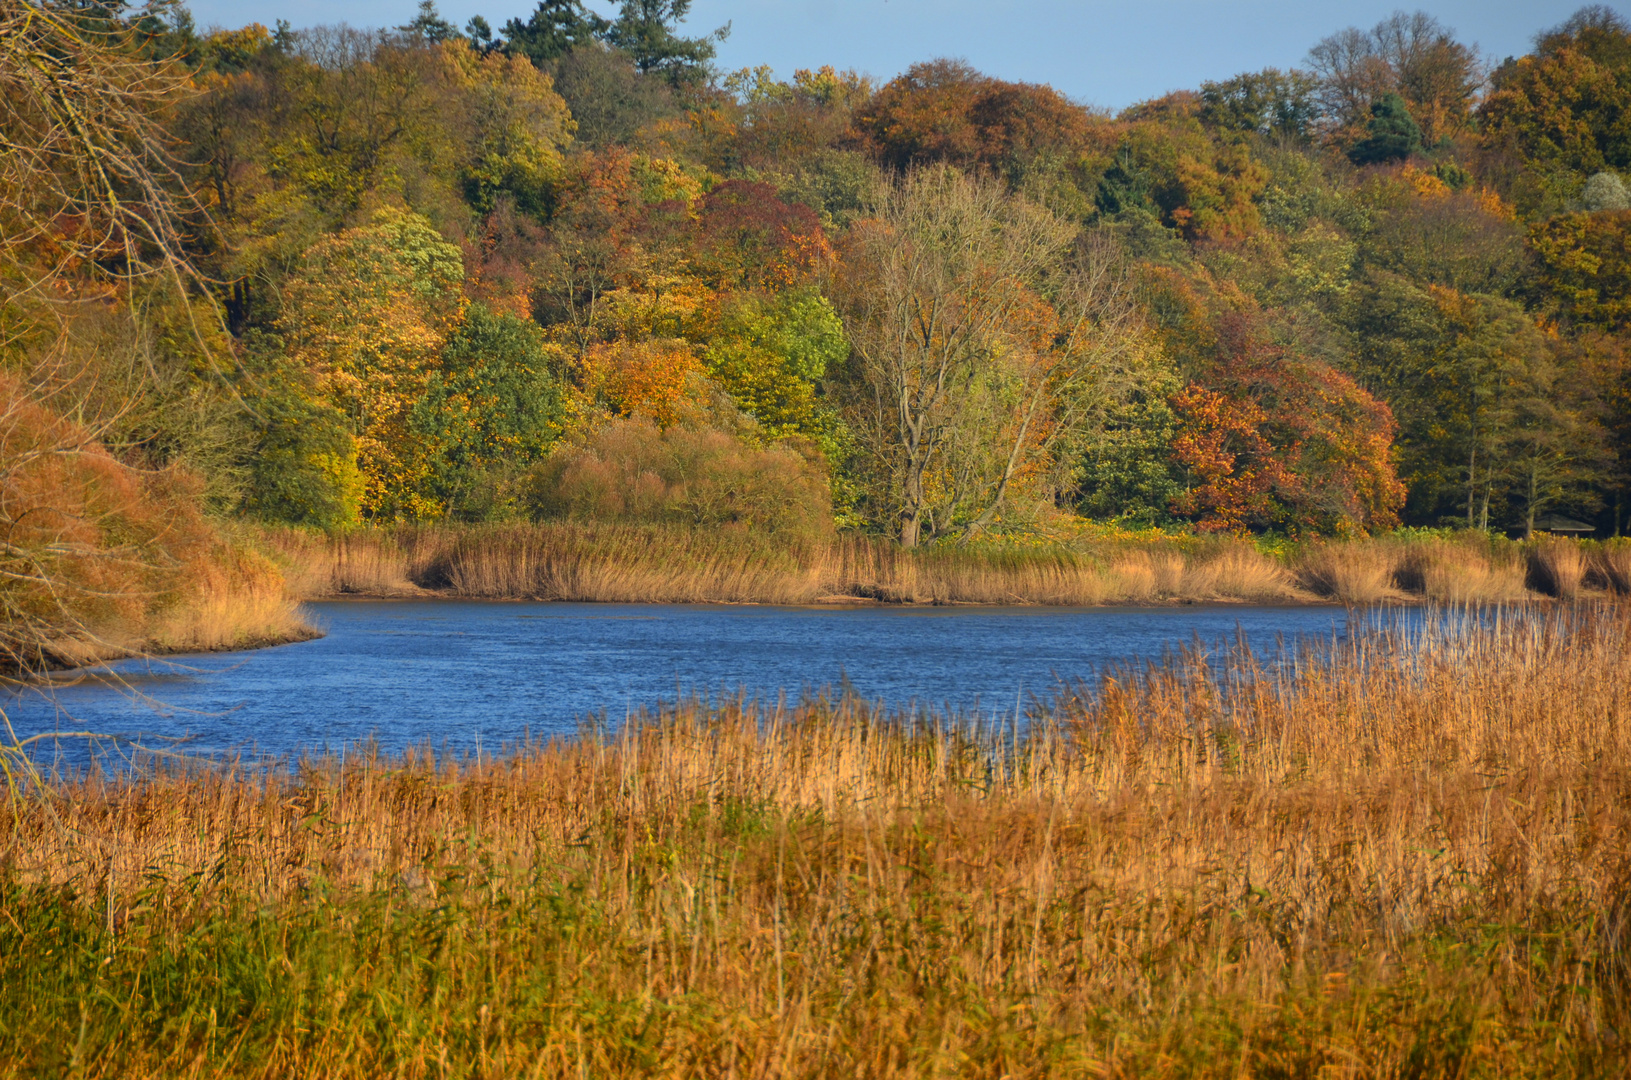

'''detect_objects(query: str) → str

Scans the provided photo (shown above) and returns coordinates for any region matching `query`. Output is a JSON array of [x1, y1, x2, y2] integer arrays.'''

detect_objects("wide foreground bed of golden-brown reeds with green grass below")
[[9, 603, 1631, 1078]]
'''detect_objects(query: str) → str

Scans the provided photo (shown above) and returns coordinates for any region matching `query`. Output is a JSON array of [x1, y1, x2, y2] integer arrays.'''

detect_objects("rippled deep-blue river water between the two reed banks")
[[5, 600, 1347, 764]]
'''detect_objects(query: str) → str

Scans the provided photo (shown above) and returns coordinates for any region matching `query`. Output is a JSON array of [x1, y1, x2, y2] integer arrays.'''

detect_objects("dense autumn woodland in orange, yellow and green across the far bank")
[[0, 0, 1631, 545]]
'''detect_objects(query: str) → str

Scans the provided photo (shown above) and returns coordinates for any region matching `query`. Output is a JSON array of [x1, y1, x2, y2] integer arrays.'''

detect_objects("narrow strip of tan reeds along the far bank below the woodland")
[[261, 522, 1631, 605]]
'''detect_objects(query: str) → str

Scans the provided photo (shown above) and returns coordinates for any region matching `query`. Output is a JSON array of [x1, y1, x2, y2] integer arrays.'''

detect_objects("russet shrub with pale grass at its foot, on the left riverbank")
[[0, 374, 305, 675]]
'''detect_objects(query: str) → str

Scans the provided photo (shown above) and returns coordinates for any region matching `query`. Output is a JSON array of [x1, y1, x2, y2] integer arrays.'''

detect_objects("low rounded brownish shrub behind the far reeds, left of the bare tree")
[[524, 419, 832, 538]]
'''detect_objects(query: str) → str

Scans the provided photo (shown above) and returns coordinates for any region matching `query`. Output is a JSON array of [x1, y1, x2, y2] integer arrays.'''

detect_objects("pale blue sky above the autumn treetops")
[[181, 0, 1631, 108]]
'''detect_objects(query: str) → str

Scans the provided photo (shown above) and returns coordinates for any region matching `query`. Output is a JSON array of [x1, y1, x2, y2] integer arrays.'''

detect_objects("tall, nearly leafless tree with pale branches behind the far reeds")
[[835, 166, 1154, 547]]
